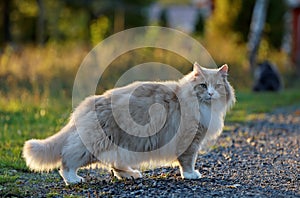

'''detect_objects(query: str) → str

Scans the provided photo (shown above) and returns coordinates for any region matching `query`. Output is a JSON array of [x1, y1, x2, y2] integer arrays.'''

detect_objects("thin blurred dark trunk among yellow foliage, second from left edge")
[[36, 0, 45, 45]]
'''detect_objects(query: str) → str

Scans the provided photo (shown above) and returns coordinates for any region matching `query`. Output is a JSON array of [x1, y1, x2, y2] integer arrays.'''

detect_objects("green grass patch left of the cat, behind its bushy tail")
[[0, 96, 71, 172]]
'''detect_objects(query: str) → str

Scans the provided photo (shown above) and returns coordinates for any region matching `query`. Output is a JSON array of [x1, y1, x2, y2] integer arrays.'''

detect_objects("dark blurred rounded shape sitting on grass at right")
[[253, 61, 282, 92]]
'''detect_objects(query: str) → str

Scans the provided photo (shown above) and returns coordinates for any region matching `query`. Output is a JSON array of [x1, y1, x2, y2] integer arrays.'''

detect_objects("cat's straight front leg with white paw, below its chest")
[[178, 138, 201, 179]]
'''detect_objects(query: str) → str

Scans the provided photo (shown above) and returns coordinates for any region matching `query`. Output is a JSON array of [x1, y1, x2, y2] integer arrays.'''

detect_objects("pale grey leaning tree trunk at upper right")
[[248, 0, 269, 73]]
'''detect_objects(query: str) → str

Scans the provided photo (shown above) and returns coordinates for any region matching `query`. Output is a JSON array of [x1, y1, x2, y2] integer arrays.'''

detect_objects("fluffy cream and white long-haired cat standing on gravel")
[[23, 62, 235, 185]]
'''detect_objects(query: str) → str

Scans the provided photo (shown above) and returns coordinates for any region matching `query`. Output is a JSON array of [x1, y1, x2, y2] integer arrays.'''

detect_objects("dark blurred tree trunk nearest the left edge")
[[2, 0, 11, 44]]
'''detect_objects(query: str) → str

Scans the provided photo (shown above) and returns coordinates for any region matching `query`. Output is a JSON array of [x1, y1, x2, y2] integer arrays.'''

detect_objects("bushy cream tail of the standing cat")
[[23, 125, 72, 171]]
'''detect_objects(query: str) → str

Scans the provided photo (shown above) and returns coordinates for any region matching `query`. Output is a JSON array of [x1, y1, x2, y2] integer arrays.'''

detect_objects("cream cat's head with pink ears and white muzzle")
[[189, 62, 235, 106]]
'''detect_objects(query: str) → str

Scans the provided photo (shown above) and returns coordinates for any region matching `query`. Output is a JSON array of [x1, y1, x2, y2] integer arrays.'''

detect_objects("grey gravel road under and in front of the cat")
[[3, 107, 300, 197]]
